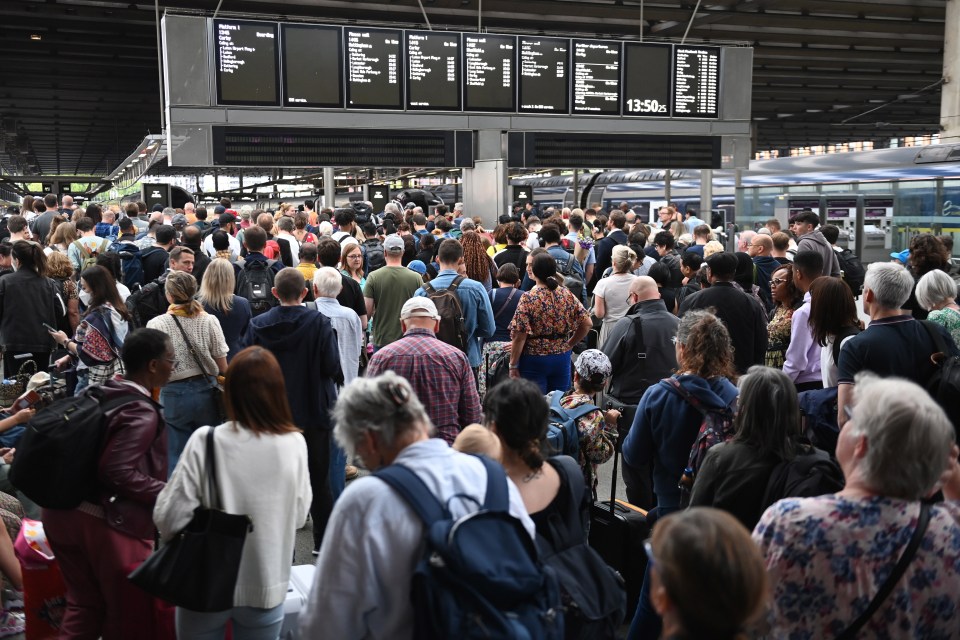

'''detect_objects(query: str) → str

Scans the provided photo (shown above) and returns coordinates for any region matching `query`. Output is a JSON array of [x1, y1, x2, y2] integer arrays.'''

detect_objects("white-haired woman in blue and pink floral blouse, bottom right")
[[753, 376, 960, 638]]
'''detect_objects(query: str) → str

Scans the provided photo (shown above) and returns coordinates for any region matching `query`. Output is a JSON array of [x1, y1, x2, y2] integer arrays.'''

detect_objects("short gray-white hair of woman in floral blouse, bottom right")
[[850, 376, 955, 500]]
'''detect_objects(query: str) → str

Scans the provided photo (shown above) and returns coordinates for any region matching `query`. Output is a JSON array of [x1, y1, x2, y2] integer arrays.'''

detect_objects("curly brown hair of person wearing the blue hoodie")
[[677, 310, 737, 381]]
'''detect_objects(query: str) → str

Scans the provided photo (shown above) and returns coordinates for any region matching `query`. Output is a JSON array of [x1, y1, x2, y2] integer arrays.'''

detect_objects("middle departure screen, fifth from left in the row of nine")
[[463, 33, 517, 111]]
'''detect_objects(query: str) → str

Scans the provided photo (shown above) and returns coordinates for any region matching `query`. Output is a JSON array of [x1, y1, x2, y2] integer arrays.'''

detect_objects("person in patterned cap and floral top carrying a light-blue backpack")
[[560, 349, 620, 499]]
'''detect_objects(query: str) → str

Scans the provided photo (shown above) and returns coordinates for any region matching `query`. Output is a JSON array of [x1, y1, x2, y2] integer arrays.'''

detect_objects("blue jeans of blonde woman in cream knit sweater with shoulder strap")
[[160, 378, 220, 477]]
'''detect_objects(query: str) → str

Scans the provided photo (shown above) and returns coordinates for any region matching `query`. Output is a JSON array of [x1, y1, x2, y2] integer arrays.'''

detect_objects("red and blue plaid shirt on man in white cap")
[[366, 328, 480, 444]]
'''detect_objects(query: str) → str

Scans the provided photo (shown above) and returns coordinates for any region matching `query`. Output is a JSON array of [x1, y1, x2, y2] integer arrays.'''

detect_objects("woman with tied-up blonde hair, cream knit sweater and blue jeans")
[[147, 270, 229, 472]]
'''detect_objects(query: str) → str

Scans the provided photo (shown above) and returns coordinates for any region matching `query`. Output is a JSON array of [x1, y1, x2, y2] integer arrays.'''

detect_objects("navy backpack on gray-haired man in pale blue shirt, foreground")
[[374, 457, 563, 640]]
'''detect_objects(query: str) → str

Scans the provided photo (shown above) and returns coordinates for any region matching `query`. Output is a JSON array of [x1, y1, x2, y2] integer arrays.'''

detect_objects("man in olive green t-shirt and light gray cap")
[[363, 235, 423, 349]]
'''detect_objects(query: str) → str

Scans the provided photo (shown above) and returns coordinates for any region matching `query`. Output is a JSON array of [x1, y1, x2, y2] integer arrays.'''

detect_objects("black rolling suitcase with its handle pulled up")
[[590, 422, 650, 618]]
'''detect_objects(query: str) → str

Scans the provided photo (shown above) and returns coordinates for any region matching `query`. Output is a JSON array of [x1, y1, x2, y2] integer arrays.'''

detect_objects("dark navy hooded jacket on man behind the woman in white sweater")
[[248, 305, 343, 430]]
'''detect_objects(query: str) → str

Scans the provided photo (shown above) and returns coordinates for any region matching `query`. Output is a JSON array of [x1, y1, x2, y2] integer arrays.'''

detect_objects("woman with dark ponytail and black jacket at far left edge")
[[0, 240, 69, 378]]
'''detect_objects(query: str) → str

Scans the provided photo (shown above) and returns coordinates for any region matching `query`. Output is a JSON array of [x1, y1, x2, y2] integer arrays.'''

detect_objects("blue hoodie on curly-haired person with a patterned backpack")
[[623, 374, 737, 512]]
